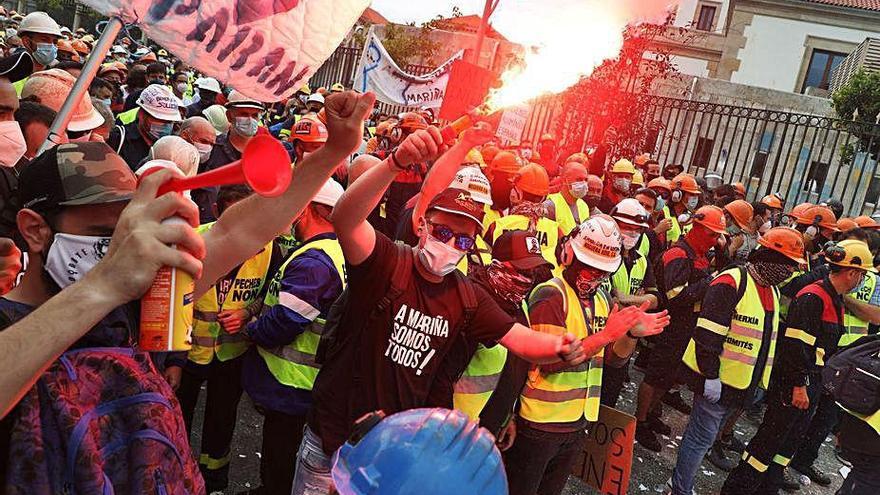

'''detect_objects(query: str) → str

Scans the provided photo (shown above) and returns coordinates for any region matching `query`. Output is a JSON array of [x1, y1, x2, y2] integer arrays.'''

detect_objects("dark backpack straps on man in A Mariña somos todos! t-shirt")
[[315, 244, 477, 364]]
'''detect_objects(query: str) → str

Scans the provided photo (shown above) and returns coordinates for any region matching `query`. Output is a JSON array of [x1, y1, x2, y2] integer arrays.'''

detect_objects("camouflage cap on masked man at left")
[[19, 142, 137, 210]]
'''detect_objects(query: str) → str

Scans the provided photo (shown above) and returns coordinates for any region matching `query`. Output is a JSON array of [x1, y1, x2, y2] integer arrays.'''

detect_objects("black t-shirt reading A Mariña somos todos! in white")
[[309, 232, 515, 453]]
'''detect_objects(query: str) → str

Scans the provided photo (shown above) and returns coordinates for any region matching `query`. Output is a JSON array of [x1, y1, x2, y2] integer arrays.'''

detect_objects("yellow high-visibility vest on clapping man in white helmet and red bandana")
[[519, 278, 610, 423]]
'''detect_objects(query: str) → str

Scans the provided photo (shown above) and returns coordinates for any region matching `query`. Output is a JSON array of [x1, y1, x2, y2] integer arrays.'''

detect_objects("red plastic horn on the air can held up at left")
[[159, 135, 293, 198]]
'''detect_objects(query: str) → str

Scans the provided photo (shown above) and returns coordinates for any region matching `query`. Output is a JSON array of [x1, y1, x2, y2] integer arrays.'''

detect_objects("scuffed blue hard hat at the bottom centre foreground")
[[332, 408, 507, 495]]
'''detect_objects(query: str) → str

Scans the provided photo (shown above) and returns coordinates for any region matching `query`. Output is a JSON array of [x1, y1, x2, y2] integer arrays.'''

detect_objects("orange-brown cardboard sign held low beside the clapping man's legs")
[[572, 406, 636, 495]]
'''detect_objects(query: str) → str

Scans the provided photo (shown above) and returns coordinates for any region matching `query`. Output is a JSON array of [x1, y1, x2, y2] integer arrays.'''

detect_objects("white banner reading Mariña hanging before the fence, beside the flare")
[[354, 28, 464, 108]]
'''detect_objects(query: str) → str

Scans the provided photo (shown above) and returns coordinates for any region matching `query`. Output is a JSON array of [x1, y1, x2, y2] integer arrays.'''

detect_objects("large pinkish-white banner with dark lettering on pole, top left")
[[80, 0, 370, 102]]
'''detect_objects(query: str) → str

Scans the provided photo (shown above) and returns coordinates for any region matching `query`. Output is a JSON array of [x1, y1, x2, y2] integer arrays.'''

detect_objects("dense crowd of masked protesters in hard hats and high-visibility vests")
[[0, 10, 880, 495]]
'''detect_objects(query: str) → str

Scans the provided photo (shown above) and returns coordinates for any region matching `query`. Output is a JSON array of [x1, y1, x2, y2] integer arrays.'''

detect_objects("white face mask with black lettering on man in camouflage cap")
[[44, 234, 110, 289]]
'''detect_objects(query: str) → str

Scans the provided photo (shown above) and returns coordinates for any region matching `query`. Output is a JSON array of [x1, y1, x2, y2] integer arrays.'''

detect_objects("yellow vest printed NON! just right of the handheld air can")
[[187, 223, 272, 364]]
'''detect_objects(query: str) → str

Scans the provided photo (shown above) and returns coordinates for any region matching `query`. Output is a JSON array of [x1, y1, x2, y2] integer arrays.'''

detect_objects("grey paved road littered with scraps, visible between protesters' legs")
[[192, 371, 843, 495]]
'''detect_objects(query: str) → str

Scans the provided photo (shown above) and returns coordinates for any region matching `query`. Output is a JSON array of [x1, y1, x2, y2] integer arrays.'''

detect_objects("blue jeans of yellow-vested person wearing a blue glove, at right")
[[672, 394, 732, 495]]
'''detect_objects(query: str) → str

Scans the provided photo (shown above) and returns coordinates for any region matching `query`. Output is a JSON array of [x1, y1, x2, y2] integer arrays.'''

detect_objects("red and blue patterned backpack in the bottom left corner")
[[5, 347, 205, 495]]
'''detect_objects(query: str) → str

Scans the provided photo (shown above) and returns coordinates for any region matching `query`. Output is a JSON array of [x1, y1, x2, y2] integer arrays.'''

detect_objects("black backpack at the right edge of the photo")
[[822, 335, 880, 415]]
